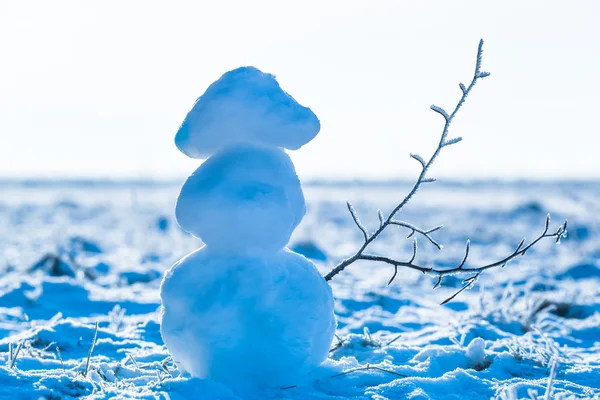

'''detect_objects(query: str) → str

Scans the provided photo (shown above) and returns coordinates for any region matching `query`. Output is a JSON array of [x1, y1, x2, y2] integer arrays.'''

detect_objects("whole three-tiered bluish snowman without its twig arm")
[[160, 67, 336, 390]]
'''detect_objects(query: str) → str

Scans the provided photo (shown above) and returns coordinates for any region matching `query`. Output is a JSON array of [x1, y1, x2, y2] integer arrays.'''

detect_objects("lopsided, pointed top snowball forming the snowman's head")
[[175, 67, 321, 158]]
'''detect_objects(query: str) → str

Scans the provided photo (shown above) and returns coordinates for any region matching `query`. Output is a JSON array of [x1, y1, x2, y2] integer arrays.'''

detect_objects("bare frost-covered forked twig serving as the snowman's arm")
[[325, 39, 567, 304]]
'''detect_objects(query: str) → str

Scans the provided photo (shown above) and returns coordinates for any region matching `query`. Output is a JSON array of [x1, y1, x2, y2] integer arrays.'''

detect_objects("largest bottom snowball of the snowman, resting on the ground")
[[161, 246, 336, 390]]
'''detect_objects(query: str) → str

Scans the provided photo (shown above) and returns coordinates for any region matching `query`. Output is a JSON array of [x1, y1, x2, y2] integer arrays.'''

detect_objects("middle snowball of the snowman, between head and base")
[[175, 145, 306, 252]]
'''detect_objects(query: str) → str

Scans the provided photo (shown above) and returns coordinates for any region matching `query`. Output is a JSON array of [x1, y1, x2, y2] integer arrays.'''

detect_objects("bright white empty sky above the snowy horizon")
[[0, 0, 600, 179]]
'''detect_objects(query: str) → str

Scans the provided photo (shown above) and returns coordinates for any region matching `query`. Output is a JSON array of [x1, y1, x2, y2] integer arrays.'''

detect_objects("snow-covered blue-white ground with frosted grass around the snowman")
[[0, 182, 600, 399]]
